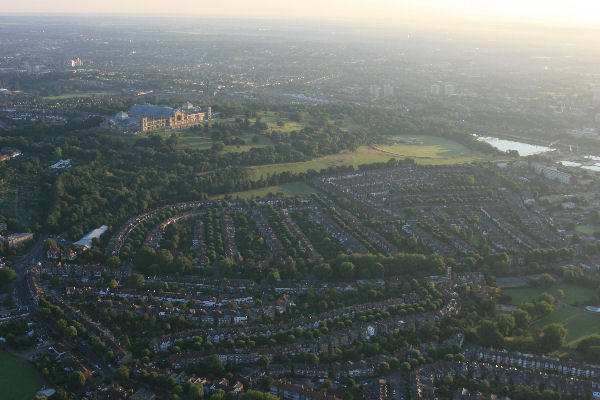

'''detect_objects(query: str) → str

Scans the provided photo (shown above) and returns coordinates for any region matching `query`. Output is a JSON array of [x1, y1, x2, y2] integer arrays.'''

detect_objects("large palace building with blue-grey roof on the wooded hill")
[[108, 102, 212, 133]]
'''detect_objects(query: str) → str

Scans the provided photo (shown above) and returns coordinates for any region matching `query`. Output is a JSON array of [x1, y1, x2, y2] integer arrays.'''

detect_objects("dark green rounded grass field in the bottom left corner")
[[0, 352, 42, 400]]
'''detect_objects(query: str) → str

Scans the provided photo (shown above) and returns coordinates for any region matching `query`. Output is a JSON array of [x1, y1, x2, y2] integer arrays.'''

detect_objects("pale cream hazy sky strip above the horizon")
[[0, 0, 600, 26]]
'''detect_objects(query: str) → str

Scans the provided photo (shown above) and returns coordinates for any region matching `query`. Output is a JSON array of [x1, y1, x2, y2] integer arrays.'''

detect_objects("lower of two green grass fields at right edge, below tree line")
[[533, 307, 600, 345]]
